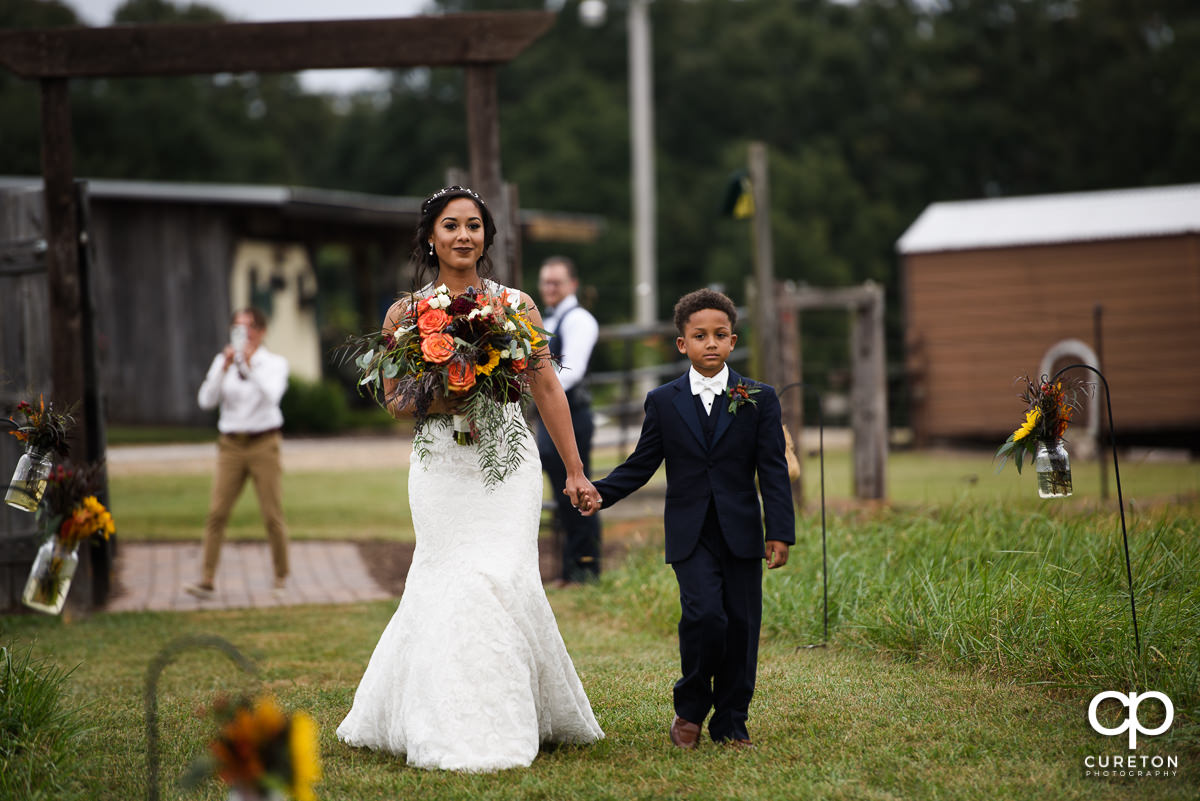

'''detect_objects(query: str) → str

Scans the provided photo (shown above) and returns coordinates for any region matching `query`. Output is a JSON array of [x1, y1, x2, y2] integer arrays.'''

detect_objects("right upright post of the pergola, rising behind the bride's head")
[[467, 64, 514, 287]]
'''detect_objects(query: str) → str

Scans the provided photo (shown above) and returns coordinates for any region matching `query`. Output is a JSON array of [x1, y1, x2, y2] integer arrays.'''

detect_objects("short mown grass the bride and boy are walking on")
[[4, 585, 1196, 801]]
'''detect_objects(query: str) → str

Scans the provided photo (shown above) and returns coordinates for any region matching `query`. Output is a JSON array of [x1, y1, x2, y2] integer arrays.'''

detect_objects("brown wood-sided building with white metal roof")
[[898, 185, 1200, 452]]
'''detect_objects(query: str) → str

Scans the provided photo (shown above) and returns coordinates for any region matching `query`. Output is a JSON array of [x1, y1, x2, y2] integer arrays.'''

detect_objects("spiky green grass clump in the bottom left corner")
[[0, 646, 85, 801]]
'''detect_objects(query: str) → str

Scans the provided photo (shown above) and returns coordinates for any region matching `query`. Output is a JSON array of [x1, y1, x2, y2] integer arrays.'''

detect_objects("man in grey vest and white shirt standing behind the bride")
[[538, 255, 600, 585]]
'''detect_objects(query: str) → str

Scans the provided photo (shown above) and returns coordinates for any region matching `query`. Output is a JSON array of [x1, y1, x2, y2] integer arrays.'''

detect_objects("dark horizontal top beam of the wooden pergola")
[[0, 11, 556, 78]]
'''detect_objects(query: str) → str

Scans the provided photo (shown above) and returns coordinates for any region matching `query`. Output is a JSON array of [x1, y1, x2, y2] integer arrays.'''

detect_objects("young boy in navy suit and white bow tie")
[[595, 289, 796, 748]]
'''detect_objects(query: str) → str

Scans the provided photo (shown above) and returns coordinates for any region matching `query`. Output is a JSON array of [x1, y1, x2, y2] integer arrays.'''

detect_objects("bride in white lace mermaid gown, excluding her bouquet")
[[337, 186, 604, 771]]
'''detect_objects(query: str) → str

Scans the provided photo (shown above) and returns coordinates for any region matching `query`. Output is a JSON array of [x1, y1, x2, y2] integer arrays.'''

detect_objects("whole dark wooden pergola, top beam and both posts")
[[0, 12, 554, 459]]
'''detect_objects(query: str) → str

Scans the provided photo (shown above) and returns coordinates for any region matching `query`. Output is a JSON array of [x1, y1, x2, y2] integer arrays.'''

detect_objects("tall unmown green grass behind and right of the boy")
[[576, 504, 1200, 748]]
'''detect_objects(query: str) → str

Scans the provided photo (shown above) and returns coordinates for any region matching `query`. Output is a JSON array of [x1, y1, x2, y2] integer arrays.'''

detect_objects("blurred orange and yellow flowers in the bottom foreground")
[[182, 697, 320, 801]]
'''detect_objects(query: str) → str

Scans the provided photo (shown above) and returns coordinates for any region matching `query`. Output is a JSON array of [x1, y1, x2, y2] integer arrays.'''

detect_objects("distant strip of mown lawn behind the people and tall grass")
[[110, 448, 1200, 542]]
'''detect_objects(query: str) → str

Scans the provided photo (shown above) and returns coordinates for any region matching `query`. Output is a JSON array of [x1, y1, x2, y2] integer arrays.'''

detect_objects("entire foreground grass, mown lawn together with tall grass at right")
[[0, 491, 1200, 801]]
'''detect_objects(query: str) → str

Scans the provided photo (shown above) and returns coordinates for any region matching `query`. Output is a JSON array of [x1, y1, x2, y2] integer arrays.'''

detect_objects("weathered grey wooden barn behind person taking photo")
[[0, 177, 599, 424]]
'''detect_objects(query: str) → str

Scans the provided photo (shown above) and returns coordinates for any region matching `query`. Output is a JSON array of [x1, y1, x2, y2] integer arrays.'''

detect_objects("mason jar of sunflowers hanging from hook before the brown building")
[[996, 375, 1092, 498]]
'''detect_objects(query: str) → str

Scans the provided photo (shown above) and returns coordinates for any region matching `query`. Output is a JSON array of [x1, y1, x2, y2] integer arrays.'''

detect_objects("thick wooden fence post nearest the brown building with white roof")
[[850, 282, 888, 499]]
